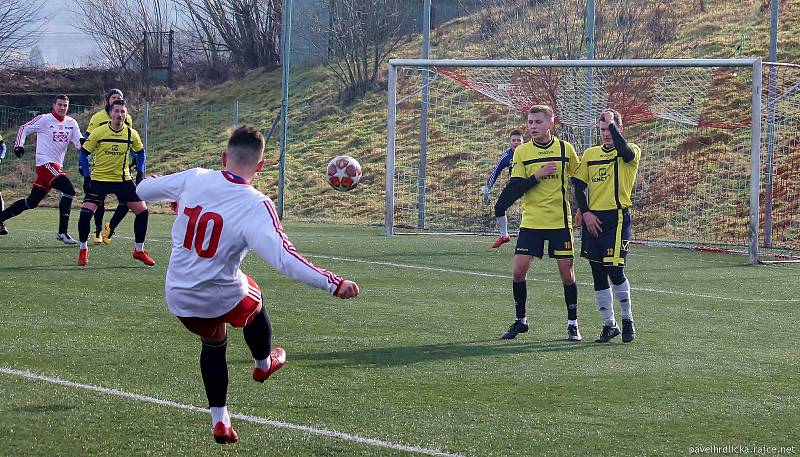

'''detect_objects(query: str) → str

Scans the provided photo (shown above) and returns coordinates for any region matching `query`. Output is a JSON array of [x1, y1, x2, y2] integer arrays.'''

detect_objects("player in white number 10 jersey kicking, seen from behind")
[[136, 126, 359, 444]]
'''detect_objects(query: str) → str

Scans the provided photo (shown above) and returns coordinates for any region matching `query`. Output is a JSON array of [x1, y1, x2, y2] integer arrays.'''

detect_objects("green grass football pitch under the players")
[[0, 209, 800, 456]]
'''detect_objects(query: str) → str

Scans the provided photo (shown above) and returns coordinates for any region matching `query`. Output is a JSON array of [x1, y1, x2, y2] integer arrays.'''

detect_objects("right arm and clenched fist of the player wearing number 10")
[[246, 200, 359, 298]]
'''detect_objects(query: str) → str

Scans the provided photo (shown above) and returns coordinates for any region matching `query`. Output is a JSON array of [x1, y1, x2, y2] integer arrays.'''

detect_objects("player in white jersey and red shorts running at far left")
[[0, 95, 82, 244]]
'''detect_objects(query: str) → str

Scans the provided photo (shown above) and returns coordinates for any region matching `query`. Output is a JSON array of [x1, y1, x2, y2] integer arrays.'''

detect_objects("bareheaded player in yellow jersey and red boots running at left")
[[78, 100, 155, 266]]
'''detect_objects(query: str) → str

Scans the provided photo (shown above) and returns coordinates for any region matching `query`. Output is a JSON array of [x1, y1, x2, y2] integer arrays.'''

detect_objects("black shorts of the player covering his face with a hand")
[[581, 209, 632, 267]]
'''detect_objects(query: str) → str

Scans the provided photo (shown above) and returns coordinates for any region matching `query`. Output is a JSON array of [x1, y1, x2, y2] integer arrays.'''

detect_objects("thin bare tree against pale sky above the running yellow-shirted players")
[[76, 0, 177, 67]]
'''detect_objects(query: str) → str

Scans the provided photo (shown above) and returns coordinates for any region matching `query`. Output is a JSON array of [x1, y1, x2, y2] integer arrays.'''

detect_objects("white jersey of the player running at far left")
[[14, 113, 83, 167]]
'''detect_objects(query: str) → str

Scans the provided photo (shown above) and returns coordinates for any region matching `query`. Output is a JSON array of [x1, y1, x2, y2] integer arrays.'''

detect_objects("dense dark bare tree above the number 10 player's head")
[[176, 0, 283, 69]]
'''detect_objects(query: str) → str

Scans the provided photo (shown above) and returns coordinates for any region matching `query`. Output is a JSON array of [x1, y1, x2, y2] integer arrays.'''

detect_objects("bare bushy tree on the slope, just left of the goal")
[[304, 0, 414, 103]]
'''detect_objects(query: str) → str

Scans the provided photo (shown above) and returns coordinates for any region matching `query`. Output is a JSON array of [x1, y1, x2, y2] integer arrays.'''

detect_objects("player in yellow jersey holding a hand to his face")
[[573, 109, 642, 343]]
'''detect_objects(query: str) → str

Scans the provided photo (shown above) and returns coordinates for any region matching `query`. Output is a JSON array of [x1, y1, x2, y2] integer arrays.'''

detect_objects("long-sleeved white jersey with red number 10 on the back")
[[136, 168, 343, 318]]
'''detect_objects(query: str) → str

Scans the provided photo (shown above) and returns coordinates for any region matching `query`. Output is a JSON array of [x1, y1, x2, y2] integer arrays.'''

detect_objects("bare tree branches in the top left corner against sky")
[[0, 0, 49, 67]]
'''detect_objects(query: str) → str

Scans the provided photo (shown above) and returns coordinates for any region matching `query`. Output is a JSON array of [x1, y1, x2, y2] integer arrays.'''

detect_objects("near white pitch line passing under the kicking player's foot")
[[0, 366, 464, 457]]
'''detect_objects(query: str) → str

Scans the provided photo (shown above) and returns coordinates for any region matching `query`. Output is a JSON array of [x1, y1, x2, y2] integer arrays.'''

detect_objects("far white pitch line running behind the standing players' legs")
[[12, 229, 800, 303]]
